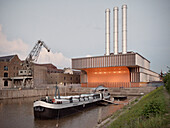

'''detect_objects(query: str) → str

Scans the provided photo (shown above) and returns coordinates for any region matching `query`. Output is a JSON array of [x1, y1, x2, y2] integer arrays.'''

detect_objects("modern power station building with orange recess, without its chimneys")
[[72, 52, 160, 87]]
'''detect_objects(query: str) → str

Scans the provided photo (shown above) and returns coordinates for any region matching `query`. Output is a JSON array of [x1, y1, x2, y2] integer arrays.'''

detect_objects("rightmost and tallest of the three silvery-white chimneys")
[[122, 5, 127, 54]]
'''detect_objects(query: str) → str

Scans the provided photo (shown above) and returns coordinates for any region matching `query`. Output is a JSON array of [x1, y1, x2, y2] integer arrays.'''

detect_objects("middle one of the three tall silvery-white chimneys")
[[113, 7, 119, 55]]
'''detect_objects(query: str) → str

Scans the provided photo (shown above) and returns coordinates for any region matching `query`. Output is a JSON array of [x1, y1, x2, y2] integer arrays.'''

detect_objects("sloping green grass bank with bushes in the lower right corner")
[[108, 87, 167, 128]]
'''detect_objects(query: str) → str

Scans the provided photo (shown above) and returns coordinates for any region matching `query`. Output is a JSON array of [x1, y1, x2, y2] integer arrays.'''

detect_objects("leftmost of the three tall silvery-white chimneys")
[[105, 9, 110, 55]]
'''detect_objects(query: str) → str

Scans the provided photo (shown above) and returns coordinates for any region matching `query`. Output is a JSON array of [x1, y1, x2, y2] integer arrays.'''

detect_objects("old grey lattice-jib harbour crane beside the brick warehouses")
[[18, 40, 50, 86]]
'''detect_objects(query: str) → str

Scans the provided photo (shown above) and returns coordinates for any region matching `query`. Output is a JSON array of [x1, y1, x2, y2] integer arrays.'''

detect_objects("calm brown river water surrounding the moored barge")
[[0, 97, 123, 128]]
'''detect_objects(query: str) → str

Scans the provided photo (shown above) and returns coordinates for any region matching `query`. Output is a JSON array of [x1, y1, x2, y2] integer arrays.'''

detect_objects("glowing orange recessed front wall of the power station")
[[82, 66, 130, 87]]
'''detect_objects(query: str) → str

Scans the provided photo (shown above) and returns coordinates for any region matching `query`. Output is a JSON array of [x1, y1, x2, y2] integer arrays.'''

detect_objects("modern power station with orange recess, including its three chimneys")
[[72, 5, 160, 87]]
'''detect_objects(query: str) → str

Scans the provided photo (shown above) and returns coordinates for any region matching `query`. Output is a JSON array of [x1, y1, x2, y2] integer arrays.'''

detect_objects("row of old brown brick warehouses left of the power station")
[[0, 55, 80, 89]]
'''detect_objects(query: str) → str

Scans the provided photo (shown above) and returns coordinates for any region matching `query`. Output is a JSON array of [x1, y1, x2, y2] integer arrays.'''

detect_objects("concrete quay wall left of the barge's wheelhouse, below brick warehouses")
[[0, 87, 90, 99]]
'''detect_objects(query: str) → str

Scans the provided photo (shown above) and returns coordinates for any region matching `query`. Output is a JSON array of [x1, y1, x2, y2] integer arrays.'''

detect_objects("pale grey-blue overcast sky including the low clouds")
[[0, 0, 170, 73]]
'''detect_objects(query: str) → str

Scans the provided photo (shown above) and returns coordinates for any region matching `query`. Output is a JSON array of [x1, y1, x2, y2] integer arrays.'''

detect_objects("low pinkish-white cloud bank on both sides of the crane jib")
[[0, 25, 71, 68]]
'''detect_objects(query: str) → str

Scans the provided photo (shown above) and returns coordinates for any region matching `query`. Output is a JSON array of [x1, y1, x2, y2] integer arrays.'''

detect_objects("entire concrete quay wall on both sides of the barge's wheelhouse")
[[0, 87, 155, 99]]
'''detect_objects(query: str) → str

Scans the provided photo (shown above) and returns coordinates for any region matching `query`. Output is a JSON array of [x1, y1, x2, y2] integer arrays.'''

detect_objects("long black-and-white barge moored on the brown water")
[[33, 86, 110, 119]]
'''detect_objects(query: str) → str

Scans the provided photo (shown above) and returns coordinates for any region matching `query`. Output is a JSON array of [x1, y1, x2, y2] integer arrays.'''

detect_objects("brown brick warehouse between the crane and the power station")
[[34, 64, 80, 86]]
